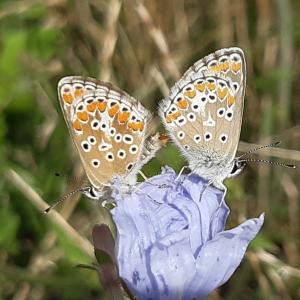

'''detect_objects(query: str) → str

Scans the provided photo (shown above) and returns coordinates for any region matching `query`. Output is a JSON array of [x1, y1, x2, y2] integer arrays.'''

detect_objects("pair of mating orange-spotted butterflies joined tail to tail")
[[58, 48, 246, 199]]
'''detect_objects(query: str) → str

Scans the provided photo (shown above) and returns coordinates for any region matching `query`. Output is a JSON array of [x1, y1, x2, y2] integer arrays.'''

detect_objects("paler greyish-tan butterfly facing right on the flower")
[[159, 47, 246, 190]]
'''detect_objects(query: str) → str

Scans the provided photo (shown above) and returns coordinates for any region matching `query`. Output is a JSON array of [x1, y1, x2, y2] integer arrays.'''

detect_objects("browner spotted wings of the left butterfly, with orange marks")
[[58, 76, 150, 188]]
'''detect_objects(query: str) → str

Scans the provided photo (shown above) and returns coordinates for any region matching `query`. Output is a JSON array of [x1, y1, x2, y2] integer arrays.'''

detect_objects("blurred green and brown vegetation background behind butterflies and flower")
[[0, 0, 300, 300]]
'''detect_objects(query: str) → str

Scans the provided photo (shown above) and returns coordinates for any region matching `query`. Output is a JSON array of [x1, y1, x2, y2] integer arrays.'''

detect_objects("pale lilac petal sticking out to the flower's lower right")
[[184, 214, 264, 299]]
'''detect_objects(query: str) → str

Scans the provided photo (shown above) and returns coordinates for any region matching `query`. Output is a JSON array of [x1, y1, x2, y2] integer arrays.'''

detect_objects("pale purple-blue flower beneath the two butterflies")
[[112, 168, 264, 300]]
